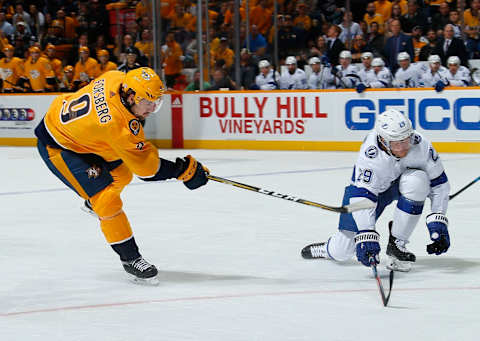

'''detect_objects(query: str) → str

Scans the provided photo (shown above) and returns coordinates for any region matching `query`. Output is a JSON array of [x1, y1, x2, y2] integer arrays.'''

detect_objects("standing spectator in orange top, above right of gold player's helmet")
[[162, 32, 184, 88]]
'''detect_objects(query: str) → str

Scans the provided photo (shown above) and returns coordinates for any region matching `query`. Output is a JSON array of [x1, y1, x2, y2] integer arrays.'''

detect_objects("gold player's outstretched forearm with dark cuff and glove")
[[140, 155, 210, 190]]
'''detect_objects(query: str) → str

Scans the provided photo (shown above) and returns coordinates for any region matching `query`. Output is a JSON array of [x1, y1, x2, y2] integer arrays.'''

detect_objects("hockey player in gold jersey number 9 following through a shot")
[[35, 67, 208, 281]]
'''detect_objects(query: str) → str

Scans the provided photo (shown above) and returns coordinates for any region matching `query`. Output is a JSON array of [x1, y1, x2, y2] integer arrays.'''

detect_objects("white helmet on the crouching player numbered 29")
[[375, 109, 413, 152]]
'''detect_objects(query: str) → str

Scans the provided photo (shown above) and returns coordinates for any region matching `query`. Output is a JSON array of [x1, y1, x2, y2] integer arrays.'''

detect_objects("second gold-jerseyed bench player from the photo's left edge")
[[24, 46, 56, 92]]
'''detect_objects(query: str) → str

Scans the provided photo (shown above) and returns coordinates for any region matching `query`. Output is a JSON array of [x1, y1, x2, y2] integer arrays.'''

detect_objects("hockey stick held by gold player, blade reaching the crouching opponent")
[[207, 175, 376, 213]]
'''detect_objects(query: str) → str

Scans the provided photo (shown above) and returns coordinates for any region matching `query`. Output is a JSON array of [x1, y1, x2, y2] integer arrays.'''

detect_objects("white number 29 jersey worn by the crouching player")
[[351, 131, 450, 230]]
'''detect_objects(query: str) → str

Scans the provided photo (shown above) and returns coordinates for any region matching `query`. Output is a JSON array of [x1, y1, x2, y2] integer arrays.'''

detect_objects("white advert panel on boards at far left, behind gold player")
[[0, 95, 55, 138]]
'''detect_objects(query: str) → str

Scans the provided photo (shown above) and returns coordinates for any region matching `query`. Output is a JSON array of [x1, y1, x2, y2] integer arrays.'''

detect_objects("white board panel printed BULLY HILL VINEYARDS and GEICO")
[[183, 89, 480, 141]]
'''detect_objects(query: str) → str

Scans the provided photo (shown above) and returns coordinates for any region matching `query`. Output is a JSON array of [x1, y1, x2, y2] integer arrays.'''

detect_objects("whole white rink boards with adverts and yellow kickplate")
[[0, 88, 480, 153]]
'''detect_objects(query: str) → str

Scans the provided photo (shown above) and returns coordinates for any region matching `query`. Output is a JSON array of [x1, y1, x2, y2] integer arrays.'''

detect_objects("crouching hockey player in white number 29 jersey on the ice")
[[301, 109, 450, 271]]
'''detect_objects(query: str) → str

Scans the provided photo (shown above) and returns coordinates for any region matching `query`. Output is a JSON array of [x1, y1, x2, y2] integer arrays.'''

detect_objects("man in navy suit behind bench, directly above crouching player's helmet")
[[384, 19, 414, 73]]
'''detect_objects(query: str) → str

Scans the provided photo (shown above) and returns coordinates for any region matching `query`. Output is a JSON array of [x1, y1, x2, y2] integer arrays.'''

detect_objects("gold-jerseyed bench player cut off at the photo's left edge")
[[0, 44, 26, 92]]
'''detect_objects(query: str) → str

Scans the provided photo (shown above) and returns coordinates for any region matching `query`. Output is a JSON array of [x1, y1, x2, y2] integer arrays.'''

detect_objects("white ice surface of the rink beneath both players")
[[0, 148, 480, 341]]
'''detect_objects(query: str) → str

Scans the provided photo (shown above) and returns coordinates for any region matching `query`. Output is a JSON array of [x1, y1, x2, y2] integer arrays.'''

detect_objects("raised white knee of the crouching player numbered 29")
[[400, 169, 430, 202]]
